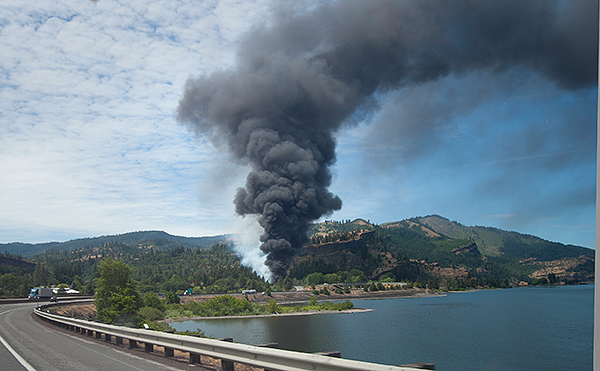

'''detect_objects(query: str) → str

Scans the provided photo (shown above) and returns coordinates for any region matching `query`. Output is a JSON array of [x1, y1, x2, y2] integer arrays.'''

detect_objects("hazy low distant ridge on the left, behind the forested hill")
[[0, 231, 230, 257]]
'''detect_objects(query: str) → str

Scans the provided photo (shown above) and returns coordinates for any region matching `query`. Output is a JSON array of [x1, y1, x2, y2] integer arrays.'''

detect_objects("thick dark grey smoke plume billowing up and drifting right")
[[178, 0, 598, 277]]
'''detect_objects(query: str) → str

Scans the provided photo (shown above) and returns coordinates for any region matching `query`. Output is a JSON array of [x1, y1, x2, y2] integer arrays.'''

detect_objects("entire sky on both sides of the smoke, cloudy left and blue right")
[[0, 0, 598, 258]]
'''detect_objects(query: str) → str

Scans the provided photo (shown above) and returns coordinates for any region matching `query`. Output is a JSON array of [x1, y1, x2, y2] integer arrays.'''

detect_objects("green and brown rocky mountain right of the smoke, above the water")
[[298, 215, 595, 285]]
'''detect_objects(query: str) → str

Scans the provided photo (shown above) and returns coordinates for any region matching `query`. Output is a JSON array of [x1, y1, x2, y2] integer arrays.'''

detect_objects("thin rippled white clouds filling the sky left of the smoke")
[[0, 0, 270, 242]]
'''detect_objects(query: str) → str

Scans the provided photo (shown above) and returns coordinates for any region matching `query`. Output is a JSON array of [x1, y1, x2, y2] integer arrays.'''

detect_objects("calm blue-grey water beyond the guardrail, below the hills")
[[172, 285, 594, 371]]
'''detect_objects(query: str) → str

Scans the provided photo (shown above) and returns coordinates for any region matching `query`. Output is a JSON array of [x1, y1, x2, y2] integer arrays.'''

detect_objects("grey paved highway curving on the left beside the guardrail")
[[0, 303, 189, 371]]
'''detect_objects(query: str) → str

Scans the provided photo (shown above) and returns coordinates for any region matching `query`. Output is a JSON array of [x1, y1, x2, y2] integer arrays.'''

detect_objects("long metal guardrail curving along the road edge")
[[34, 306, 432, 371]]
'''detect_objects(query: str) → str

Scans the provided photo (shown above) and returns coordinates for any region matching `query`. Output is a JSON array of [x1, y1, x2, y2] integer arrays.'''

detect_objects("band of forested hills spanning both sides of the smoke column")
[[0, 215, 594, 296]]
